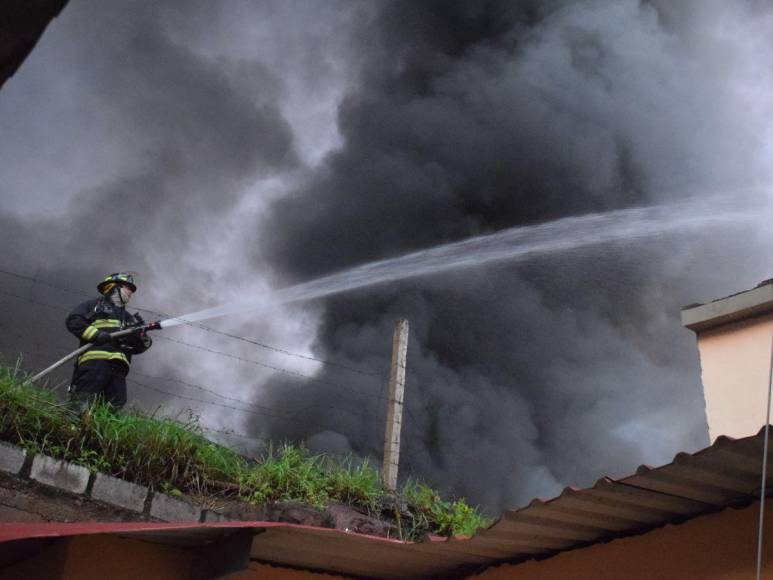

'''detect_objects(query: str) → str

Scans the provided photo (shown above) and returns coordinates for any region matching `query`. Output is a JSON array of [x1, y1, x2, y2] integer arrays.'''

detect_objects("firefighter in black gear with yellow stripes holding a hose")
[[66, 272, 152, 413]]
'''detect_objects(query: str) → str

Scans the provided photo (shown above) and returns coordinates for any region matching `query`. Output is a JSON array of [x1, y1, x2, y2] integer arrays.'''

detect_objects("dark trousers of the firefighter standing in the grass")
[[70, 360, 128, 412]]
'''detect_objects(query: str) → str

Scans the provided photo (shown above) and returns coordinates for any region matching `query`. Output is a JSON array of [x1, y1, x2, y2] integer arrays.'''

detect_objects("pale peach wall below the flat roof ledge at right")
[[698, 314, 773, 443]]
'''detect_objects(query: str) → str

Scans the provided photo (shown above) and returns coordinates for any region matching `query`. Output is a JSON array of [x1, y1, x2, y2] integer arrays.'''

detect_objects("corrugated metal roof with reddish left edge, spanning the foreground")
[[0, 431, 773, 578]]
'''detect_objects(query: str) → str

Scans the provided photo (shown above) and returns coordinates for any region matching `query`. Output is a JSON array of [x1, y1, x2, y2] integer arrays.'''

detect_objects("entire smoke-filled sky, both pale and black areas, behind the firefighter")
[[0, 0, 773, 514]]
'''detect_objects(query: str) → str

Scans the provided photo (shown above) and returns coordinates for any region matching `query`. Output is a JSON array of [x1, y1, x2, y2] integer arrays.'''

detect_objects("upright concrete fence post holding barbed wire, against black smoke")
[[381, 320, 408, 491]]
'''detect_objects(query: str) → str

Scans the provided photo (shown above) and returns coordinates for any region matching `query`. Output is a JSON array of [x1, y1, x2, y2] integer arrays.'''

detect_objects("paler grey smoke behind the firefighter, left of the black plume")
[[0, 0, 357, 431]]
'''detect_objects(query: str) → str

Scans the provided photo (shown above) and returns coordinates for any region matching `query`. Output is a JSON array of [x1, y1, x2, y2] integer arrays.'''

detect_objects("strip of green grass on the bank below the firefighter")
[[0, 365, 491, 539]]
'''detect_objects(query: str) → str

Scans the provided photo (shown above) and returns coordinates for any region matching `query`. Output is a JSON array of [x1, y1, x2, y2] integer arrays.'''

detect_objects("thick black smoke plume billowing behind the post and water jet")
[[261, 1, 766, 508]]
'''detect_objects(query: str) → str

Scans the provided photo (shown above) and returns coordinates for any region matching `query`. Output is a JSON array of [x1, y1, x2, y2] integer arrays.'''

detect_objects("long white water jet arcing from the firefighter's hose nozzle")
[[161, 200, 762, 328]]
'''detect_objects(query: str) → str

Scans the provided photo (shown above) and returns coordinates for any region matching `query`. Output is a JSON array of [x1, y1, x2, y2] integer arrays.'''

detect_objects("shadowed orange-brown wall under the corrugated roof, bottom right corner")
[[472, 502, 773, 580]]
